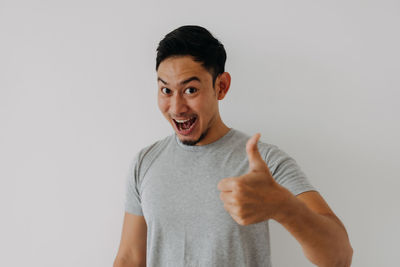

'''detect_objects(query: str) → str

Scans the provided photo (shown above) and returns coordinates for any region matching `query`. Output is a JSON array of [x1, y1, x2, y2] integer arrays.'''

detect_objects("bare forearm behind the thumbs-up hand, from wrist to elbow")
[[273, 192, 353, 267]]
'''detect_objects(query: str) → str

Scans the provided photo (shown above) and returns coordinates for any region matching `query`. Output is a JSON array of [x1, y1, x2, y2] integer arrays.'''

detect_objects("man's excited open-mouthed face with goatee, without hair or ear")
[[157, 56, 219, 145]]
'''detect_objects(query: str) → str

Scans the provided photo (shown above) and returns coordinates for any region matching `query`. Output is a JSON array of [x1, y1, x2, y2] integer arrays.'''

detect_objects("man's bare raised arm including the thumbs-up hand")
[[217, 134, 353, 267]]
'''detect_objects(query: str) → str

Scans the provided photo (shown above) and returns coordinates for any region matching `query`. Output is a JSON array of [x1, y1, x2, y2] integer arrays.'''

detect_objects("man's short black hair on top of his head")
[[156, 25, 226, 87]]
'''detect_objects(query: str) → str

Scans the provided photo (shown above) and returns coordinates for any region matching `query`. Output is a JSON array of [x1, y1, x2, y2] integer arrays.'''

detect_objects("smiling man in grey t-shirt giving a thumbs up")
[[114, 26, 352, 267]]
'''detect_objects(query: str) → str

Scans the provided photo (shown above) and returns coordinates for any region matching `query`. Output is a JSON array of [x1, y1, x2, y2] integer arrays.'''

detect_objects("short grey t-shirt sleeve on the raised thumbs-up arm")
[[265, 145, 316, 195]]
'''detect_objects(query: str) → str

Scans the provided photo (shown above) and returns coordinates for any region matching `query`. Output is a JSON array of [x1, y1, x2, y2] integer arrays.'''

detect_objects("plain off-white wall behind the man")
[[0, 0, 400, 267]]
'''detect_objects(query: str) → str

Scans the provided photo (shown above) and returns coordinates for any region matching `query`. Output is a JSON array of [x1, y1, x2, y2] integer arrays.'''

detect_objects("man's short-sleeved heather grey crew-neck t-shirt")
[[125, 128, 315, 267]]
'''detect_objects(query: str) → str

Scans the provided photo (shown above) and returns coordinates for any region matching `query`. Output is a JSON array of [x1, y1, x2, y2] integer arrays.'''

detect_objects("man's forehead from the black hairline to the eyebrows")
[[157, 56, 212, 83]]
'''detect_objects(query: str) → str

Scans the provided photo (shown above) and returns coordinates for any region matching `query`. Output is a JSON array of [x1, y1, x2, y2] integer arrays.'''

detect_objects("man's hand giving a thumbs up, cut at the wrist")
[[217, 133, 293, 225]]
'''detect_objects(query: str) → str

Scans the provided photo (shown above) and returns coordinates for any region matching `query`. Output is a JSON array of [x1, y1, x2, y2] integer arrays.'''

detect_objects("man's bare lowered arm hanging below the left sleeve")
[[113, 212, 147, 267]]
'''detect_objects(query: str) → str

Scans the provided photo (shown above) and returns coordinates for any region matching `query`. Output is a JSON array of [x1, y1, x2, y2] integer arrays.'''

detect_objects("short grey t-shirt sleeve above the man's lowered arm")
[[125, 154, 143, 216]]
